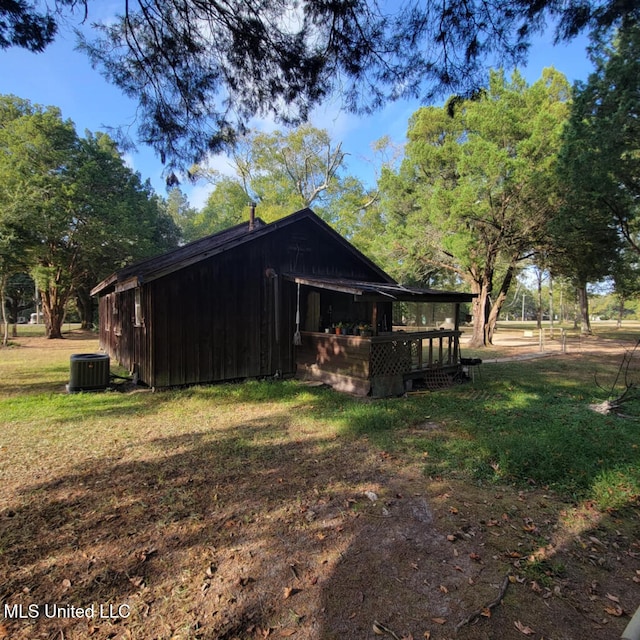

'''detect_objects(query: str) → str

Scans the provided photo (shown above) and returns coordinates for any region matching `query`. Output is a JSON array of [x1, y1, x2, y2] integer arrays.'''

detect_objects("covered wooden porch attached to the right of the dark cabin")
[[288, 276, 473, 397]]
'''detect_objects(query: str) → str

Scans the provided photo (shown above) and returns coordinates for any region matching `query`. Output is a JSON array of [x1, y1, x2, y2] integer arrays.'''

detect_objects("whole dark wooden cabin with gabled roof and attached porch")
[[92, 209, 471, 395]]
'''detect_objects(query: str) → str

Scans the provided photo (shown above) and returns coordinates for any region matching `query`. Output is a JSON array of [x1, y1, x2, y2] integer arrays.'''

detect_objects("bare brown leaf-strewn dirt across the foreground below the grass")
[[0, 332, 640, 640]]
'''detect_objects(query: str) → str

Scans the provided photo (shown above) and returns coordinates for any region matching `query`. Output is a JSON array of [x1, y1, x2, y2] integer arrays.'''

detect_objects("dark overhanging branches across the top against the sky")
[[0, 0, 638, 169]]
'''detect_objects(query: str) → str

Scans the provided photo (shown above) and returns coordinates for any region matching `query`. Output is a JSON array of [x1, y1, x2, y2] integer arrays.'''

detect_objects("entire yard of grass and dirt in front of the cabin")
[[0, 331, 640, 640]]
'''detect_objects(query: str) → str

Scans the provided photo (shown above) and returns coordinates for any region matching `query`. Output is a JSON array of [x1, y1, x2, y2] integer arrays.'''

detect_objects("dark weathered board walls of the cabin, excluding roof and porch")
[[100, 218, 390, 387]]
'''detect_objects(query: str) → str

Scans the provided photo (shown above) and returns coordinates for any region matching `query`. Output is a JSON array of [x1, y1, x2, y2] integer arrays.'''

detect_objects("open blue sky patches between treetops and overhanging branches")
[[0, 18, 592, 207]]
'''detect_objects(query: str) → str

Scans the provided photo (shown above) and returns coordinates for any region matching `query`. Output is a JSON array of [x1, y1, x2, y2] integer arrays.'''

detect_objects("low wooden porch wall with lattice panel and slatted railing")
[[296, 330, 461, 397]]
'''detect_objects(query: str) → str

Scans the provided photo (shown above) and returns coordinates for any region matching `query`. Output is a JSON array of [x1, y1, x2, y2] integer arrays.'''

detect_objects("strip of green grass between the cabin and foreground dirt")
[[0, 333, 640, 506]]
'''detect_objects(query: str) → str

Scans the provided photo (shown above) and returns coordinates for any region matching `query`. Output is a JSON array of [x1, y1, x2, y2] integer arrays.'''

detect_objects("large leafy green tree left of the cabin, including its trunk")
[[0, 96, 178, 338]]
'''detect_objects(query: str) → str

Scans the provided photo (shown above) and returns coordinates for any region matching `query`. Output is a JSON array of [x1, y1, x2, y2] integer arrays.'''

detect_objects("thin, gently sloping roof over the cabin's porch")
[[283, 274, 476, 303]]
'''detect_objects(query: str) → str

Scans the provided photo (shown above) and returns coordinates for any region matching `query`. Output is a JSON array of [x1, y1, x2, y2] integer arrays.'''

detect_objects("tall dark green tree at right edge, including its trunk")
[[549, 23, 640, 332]]
